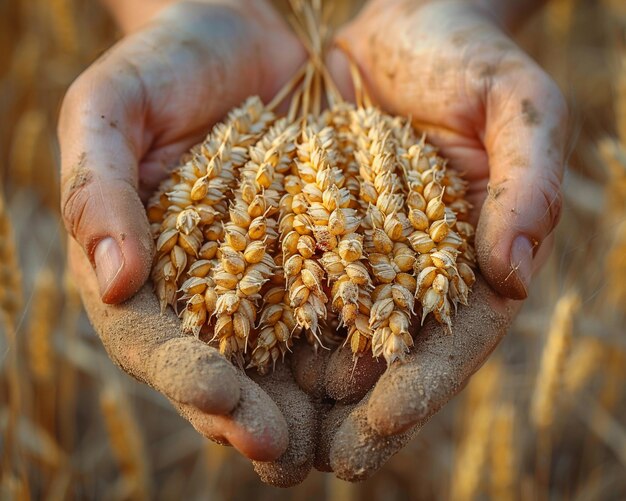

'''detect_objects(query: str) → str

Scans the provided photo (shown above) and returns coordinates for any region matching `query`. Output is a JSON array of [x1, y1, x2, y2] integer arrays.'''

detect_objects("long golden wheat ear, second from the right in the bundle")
[[352, 108, 416, 363]]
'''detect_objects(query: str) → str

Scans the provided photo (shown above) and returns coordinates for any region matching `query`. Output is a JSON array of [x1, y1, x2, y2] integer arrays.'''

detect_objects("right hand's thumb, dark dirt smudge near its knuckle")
[[476, 60, 567, 299]]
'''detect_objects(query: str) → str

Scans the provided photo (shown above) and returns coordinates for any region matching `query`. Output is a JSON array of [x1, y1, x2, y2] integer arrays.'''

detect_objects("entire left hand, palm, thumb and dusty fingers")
[[59, 1, 313, 483]]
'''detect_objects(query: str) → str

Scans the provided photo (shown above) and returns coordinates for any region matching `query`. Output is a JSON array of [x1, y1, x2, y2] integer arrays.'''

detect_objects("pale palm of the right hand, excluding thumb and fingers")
[[340, 3, 532, 224]]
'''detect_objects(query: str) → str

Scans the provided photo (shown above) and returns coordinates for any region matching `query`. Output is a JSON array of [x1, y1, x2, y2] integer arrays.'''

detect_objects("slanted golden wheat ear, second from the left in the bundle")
[[213, 119, 297, 363]]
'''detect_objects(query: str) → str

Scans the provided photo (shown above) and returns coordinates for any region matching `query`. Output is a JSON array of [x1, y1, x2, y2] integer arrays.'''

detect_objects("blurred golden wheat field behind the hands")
[[0, 0, 626, 501]]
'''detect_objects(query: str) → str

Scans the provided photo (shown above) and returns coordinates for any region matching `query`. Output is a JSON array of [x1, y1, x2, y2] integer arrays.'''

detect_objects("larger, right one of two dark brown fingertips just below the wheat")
[[324, 348, 387, 404]]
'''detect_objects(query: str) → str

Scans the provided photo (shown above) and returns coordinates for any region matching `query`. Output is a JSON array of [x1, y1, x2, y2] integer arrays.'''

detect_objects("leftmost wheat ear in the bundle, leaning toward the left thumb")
[[147, 98, 274, 312]]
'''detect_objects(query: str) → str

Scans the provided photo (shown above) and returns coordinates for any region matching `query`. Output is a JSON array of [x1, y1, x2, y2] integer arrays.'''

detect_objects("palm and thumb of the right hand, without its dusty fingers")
[[332, 0, 567, 299]]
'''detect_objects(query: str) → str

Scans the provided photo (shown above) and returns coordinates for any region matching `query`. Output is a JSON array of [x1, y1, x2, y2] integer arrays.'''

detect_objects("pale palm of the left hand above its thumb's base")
[[114, 3, 304, 194]]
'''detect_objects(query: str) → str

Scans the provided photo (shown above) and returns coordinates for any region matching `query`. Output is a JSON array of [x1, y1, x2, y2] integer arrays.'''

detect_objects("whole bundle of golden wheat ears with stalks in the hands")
[[148, 7, 474, 373]]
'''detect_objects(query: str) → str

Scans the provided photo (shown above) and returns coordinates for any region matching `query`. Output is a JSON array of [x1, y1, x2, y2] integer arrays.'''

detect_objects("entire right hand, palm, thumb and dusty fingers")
[[314, 0, 566, 480]]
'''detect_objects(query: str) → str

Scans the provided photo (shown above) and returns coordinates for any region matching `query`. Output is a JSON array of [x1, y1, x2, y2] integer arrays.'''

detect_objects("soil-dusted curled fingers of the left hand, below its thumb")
[[69, 240, 317, 486]]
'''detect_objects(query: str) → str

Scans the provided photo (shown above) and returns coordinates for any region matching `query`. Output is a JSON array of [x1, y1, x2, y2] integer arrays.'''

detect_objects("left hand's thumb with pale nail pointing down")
[[59, 62, 153, 303]]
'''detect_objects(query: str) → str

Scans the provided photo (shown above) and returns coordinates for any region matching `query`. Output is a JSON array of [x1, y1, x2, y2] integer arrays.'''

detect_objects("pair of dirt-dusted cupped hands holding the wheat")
[[59, 0, 566, 485]]
